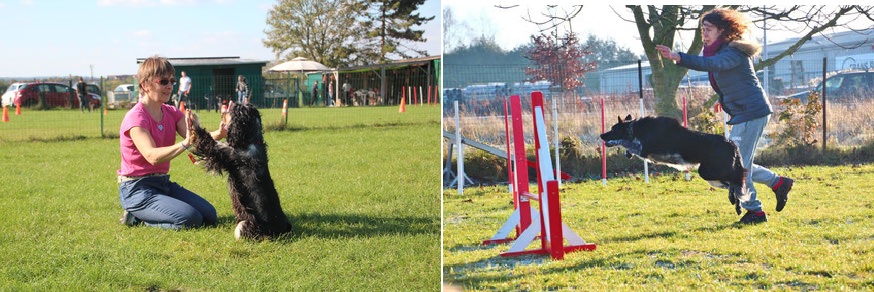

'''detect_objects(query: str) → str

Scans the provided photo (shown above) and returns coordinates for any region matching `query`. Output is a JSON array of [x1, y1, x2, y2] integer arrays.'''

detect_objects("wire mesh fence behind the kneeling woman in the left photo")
[[0, 62, 440, 143]]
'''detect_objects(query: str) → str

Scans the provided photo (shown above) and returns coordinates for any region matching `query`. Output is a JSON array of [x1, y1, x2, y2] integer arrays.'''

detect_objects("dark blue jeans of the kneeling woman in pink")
[[118, 175, 218, 229]]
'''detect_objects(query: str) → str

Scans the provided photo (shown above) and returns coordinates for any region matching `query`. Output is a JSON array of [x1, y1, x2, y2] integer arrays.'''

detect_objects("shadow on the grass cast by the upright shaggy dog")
[[218, 213, 440, 242]]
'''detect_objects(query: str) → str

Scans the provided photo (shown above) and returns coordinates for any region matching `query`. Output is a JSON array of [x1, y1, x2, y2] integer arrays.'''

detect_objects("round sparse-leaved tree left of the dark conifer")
[[263, 0, 362, 67]]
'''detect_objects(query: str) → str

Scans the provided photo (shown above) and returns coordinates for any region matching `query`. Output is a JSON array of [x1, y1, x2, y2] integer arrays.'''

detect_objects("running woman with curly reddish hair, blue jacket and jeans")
[[656, 8, 794, 224]]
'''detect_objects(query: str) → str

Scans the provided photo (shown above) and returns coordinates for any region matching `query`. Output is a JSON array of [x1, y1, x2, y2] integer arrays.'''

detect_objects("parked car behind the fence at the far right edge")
[[778, 71, 874, 103]]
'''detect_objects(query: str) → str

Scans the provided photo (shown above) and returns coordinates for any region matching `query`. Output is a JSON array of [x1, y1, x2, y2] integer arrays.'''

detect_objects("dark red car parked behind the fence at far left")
[[12, 82, 100, 108]]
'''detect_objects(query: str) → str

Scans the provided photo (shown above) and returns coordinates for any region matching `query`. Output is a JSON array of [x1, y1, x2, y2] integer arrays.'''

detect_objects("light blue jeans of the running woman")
[[728, 115, 779, 212]]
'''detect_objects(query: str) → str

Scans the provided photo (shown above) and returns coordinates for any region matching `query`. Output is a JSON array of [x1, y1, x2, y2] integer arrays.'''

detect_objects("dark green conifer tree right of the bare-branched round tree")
[[362, 0, 434, 61]]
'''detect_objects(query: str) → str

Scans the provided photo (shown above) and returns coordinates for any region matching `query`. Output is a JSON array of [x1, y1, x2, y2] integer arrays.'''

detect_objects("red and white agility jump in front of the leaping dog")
[[483, 92, 596, 260]]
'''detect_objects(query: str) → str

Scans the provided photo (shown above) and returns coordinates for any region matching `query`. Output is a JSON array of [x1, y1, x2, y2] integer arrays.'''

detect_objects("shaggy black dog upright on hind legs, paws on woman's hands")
[[191, 104, 291, 240]]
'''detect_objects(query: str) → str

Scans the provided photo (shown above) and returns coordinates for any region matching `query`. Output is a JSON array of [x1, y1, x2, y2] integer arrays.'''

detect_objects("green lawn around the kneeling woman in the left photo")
[[0, 106, 441, 291]]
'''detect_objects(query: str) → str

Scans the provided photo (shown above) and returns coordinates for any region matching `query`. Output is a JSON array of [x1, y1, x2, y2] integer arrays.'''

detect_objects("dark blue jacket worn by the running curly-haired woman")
[[677, 41, 771, 125]]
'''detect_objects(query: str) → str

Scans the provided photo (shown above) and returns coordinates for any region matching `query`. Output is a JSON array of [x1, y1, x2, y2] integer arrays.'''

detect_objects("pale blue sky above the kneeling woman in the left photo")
[[0, 0, 441, 77]]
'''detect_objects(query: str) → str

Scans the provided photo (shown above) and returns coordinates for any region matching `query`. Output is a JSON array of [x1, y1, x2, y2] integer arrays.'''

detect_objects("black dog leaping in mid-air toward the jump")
[[601, 115, 746, 215]]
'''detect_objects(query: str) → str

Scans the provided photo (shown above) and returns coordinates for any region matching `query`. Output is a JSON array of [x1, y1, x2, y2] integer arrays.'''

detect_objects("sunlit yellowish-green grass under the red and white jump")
[[443, 165, 874, 291]]
